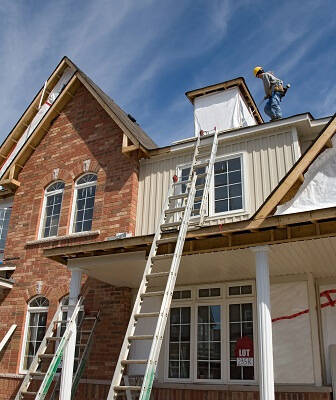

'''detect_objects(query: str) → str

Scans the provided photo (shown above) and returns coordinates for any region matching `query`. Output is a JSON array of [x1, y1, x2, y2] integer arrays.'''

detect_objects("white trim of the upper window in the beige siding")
[[176, 151, 248, 221]]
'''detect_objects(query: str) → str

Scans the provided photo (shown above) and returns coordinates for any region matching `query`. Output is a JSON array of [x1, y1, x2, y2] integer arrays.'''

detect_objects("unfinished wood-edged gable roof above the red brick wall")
[[0, 57, 157, 190]]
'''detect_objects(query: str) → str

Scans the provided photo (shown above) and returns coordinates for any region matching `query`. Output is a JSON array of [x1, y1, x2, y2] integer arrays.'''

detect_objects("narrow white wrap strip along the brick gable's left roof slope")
[[0, 68, 73, 179]]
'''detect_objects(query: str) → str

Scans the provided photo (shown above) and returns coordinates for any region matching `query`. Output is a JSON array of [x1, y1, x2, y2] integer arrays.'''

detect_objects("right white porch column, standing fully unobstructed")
[[252, 246, 274, 400]]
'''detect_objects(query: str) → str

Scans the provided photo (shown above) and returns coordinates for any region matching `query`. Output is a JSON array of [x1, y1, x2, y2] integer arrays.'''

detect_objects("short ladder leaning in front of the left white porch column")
[[15, 297, 84, 400]]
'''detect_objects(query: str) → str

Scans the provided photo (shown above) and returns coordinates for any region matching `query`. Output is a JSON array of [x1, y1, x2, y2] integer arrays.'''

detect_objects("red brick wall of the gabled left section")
[[0, 86, 138, 398]]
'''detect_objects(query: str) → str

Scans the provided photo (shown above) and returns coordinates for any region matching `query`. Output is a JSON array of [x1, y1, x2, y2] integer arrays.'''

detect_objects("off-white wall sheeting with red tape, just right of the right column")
[[271, 282, 314, 384]]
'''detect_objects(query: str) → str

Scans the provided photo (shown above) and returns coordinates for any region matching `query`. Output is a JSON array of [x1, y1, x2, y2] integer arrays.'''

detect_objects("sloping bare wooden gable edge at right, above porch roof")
[[251, 114, 336, 221]]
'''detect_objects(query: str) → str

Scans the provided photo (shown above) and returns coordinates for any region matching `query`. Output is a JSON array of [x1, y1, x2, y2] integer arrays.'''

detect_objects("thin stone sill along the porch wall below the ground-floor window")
[[153, 382, 332, 393]]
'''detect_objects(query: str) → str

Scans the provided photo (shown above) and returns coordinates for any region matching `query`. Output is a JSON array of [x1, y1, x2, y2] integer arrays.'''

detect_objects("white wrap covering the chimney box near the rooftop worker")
[[194, 87, 256, 136]]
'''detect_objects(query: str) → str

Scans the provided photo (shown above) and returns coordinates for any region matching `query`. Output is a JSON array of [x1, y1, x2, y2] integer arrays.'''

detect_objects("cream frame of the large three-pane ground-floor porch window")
[[165, 280, 258, 385]]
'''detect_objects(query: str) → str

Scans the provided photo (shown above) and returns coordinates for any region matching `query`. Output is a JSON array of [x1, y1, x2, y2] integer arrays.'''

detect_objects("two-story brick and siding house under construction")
[[0, 58, 336, 400]]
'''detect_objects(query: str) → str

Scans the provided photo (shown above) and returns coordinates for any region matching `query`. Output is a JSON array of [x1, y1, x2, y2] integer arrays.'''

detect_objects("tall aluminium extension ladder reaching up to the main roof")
[[107, 128, 218, 400]]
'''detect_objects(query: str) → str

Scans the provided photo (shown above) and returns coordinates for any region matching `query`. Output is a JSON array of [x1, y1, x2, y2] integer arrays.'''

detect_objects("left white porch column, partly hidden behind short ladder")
[[59, 270, 82, 400]]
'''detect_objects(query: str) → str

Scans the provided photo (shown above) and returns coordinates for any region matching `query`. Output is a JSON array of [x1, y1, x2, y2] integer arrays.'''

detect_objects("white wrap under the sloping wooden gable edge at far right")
[[275, 136, 336, 215]]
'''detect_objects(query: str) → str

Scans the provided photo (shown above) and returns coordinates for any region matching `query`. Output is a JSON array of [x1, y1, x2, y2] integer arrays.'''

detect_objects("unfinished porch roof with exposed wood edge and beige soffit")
[[44, 207, 336, 287]]
